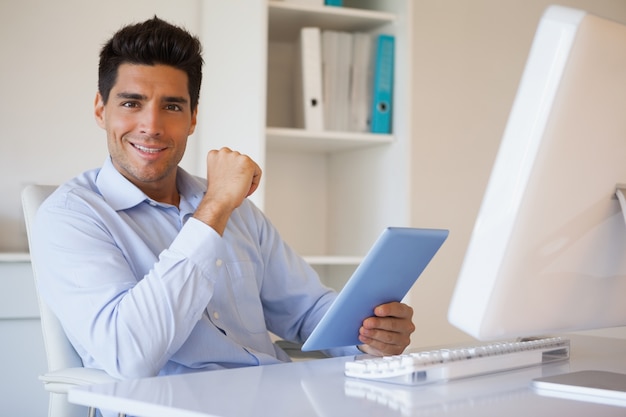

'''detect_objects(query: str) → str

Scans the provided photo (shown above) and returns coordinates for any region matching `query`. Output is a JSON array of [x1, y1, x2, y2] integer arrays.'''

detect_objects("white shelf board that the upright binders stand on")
[[266, 127, 394, 153]]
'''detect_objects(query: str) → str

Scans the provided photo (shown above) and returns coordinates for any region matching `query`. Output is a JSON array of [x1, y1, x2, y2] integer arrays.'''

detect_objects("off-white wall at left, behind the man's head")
[[0, 0, 201, 252]]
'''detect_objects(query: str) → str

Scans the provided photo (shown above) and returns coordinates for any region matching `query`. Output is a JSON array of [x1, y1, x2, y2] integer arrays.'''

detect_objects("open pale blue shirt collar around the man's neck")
[[96, 156, 206, 211]]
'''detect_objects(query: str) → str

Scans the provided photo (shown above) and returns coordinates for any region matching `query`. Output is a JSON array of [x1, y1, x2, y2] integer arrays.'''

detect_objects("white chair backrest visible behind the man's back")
[[22, 184, 83, 371]]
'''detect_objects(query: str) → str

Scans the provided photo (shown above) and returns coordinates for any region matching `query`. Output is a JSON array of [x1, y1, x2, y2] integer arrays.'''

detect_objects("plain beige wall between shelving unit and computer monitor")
[[411, 0, 626, 346]]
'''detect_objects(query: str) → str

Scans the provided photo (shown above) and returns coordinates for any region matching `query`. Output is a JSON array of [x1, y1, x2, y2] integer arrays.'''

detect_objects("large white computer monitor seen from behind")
[[448, 6, 626, 340]]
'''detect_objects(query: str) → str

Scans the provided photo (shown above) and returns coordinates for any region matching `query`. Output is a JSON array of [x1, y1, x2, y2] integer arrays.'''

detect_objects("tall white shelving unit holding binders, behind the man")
[[198, 0, 412, 288]]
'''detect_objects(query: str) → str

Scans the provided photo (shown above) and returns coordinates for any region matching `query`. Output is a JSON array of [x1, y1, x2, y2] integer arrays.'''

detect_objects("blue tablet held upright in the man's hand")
[[302, 227, 448, 351]]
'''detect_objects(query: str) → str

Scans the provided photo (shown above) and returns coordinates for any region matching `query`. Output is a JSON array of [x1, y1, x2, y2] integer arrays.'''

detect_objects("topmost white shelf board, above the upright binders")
[[268, 1, 396, 41]]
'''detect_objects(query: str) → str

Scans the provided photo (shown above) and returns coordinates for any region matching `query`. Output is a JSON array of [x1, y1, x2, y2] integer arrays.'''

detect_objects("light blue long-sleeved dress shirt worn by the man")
[[31, 159, 359, 378]]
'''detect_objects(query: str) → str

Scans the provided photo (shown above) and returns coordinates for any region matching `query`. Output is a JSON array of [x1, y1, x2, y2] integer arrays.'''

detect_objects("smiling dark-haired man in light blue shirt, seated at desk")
[[32, 17, 414, 378]]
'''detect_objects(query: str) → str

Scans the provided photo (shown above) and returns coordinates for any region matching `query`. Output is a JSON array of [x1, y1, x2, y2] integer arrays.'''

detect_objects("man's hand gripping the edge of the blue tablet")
[[359, 302, 415, 356]]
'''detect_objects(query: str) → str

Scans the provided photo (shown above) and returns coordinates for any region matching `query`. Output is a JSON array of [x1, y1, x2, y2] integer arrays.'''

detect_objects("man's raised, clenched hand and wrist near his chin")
[[194, 148, 261, 235]]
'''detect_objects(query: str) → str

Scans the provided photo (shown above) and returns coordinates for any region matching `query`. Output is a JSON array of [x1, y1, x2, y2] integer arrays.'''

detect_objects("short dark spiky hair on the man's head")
[[98, 16, 203, 111]]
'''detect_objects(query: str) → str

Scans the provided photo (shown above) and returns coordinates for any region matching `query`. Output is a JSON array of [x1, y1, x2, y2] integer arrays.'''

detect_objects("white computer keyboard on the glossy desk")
[[344, 337, 570, 385]]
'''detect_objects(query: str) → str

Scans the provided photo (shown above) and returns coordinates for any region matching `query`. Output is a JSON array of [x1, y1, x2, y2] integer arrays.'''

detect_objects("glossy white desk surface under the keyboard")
[[69, 335, 626, 417]]
